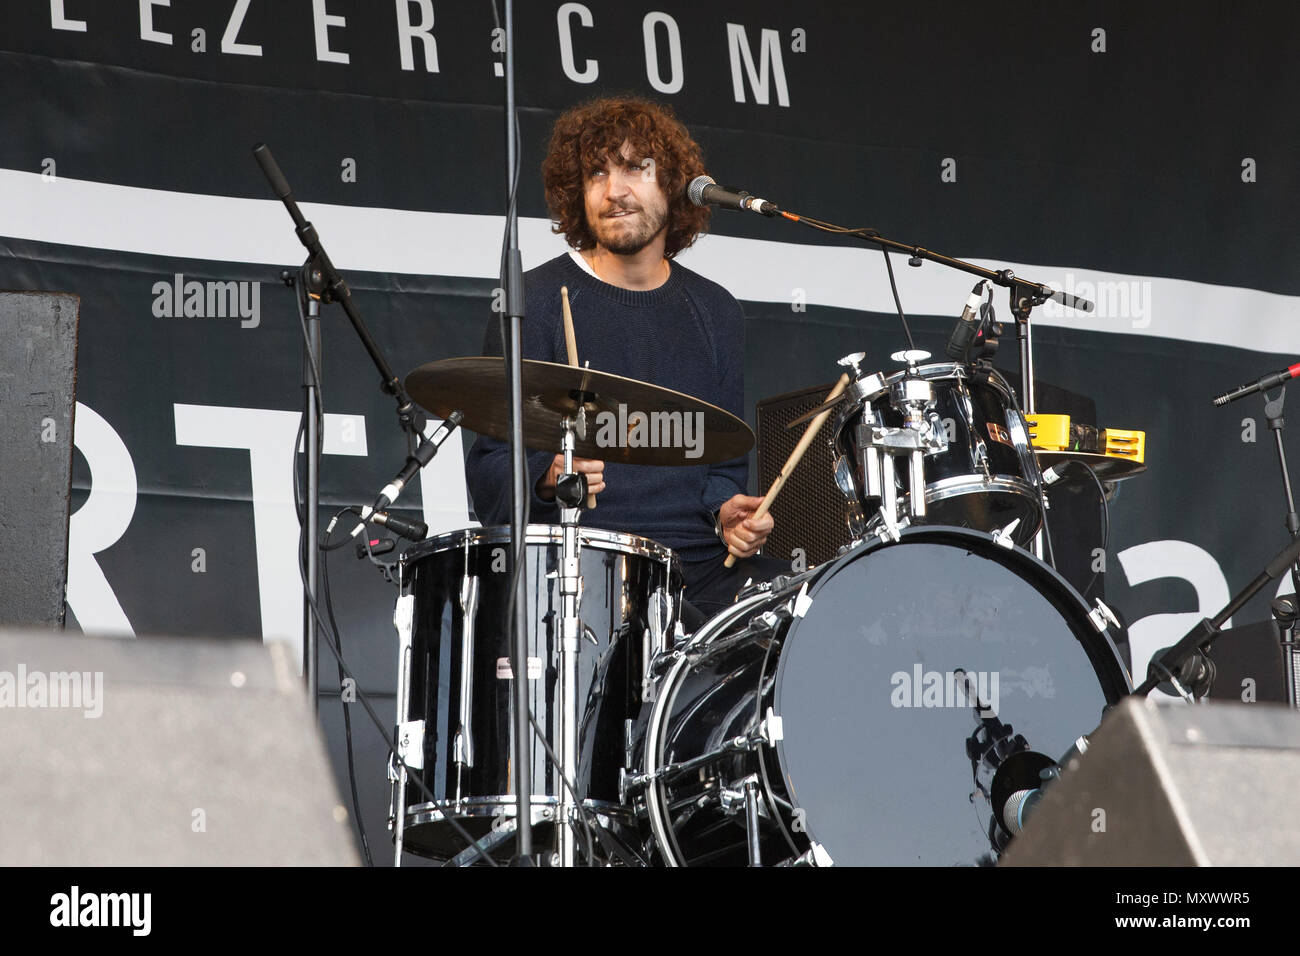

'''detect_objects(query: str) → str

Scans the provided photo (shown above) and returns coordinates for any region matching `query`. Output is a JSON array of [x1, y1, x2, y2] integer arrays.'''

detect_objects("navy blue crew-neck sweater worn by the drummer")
[[465, 254, 748, 561]]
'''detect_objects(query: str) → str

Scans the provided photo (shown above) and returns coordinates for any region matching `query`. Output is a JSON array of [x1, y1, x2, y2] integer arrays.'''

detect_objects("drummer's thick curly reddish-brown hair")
[[542, 96, 710, 259]]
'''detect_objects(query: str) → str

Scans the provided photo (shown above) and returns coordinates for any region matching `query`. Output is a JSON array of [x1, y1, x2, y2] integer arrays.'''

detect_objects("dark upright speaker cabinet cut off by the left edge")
[[0, 291, 79, 628]]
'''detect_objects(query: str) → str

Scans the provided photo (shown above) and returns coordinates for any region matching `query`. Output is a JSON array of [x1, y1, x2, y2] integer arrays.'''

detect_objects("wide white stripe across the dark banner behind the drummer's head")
[[0, 169, 1300, 355]]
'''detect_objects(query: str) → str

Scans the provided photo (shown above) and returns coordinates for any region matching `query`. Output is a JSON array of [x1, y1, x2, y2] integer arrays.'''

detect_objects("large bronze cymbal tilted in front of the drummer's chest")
[[406, 356, 754, 466]]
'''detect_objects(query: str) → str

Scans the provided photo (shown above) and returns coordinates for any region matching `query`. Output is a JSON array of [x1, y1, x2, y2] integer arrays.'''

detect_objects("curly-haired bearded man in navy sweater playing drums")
[[465, 98, 790, 621]]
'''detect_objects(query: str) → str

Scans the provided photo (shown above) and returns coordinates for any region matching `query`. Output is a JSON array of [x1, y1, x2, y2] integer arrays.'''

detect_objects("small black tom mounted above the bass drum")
[[833, 363, 1043, 545]]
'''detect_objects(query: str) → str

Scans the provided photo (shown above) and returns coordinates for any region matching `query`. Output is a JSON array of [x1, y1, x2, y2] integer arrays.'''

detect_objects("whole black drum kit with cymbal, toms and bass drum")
[[390, 323, 1149, 866]]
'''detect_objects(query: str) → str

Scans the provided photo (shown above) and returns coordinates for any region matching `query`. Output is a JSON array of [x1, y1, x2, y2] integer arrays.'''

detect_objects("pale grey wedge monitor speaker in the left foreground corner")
[[0, 631, 359, 866]]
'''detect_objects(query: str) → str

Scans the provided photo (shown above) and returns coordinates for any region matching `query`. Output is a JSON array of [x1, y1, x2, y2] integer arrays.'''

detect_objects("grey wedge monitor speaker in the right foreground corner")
[[1001, 697, 1300, 866]]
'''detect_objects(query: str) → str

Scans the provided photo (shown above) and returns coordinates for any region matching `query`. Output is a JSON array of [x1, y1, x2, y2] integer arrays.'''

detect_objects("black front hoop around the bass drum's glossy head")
[[758, 524, 1134, 858]]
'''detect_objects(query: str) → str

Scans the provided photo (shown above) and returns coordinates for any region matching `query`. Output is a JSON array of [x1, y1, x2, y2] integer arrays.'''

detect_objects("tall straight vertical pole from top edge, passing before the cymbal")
[[502, 0, 535, 866]]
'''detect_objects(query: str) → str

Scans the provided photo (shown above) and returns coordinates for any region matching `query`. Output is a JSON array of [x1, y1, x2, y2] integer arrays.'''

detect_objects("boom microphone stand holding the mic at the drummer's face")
[[762, 209, 1097, 561]]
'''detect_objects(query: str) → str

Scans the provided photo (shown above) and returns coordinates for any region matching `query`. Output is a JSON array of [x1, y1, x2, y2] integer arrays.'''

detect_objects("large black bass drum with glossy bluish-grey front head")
[[625, 525, 1131, 866]]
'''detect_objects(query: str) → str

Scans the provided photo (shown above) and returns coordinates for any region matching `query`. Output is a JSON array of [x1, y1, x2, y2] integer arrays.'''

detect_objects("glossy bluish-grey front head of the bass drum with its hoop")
[[762, 528, 1131, 866]]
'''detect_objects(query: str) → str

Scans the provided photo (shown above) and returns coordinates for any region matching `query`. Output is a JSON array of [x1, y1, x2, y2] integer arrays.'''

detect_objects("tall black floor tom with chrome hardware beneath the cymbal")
[[390, 525, 683, 861]]
